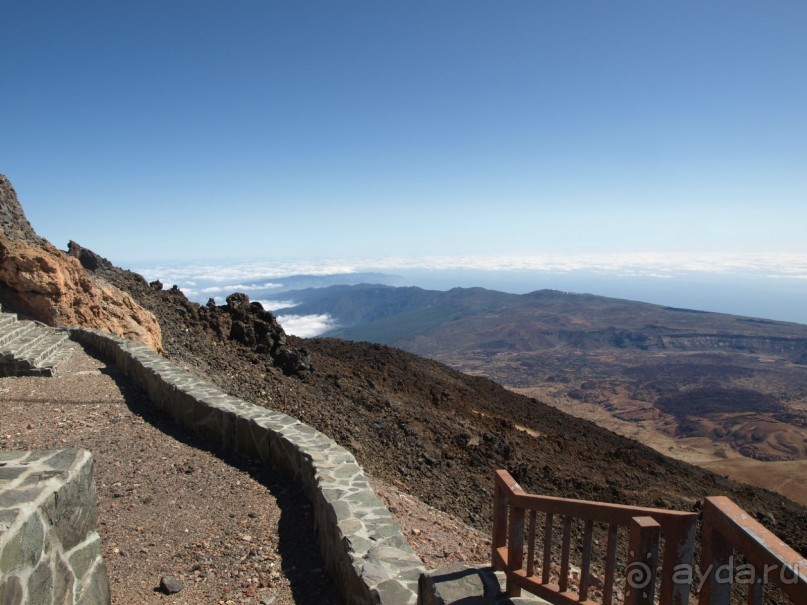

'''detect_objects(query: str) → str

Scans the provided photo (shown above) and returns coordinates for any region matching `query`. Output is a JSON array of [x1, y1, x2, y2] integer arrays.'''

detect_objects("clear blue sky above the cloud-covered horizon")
[[0, 0, 807, 262]]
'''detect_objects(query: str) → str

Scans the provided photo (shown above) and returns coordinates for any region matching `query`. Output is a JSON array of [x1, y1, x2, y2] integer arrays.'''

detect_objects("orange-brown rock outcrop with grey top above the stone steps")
[[0, 175, 162, 351]]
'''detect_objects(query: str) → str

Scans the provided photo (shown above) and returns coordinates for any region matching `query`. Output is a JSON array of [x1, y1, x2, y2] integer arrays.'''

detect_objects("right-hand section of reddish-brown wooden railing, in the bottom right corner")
[[699, 496, 807, 605]]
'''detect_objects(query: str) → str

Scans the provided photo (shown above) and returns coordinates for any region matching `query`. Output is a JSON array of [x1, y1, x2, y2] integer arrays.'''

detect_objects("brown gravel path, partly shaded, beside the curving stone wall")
[[0, 344, 341, 605]]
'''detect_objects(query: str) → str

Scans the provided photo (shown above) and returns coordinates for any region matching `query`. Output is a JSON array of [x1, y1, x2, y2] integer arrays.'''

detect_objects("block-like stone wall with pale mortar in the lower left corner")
[[0, 449, 110, 605]]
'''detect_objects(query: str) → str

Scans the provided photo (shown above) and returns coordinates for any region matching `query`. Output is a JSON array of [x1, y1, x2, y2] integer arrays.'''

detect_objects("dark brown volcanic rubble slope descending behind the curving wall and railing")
[[71, 245, 807, 553]]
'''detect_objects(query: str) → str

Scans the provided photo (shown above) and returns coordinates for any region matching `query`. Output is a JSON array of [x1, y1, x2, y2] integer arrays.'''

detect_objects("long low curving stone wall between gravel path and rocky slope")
[[70, 328, 424, 605]]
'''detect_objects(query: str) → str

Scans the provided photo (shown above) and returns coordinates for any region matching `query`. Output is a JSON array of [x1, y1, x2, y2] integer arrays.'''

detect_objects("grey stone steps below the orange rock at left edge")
[[0, 308, 72, 376]]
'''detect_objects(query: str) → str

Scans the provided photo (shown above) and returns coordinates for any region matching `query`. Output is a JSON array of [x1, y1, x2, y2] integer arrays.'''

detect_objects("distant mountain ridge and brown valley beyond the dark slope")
[[278, 284, 807, 502]]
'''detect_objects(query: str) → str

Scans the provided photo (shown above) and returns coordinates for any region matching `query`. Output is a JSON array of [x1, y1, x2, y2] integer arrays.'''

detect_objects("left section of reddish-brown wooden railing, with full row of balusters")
[[492, 471, 697, 605]]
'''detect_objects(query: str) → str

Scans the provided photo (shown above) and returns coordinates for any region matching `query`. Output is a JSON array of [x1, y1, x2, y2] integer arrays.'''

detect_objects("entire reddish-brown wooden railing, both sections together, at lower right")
[[492, 471, 807, 605]]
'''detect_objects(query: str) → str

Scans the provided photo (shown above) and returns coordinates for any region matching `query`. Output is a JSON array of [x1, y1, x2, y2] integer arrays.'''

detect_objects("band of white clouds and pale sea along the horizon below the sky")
[[135, 253, 807, 337]]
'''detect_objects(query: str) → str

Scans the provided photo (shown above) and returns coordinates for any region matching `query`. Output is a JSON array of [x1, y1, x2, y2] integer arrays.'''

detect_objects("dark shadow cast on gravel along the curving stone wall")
[[85, 349, 343, 605]]
